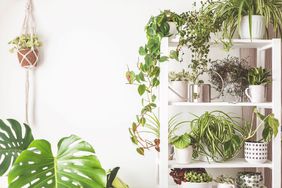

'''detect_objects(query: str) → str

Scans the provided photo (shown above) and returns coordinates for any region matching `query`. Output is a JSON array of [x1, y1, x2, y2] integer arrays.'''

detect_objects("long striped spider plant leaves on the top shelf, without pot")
[[205, 0, 282, 39]]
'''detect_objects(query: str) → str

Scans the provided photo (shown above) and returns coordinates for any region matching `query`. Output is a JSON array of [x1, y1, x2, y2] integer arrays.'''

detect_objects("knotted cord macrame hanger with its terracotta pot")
[[17, 0, 39, 124]]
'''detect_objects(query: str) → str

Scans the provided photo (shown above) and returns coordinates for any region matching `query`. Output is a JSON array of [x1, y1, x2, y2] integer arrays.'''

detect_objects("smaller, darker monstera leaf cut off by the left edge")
[[0, 119, 33, 176]]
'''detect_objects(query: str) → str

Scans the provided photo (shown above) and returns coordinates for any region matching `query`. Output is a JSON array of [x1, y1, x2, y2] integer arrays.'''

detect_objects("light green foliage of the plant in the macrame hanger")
[[9, 34, 42, 52]]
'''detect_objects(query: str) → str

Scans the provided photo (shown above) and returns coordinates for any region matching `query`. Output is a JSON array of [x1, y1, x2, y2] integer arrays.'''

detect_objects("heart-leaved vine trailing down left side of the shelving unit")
[[126, 10, 182, 155]]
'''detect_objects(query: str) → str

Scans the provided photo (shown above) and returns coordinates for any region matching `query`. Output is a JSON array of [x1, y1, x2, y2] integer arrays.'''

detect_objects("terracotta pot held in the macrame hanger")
[[18, 48, 39, 67]]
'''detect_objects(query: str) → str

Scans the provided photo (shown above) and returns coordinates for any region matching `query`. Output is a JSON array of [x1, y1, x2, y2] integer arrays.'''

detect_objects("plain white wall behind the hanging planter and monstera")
[[0, 0, 196, 188]]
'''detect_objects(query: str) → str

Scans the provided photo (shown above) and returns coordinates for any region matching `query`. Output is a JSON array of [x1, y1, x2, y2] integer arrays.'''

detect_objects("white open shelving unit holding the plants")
[[158, 38, 281, 188]]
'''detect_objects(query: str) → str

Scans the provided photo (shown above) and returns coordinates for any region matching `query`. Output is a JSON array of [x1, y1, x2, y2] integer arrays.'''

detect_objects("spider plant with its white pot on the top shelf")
[[205, 0, 282, 39]]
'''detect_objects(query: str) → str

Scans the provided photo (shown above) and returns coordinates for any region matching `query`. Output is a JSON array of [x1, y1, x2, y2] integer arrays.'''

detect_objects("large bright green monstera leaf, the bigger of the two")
[[8, 135, 106, 188]]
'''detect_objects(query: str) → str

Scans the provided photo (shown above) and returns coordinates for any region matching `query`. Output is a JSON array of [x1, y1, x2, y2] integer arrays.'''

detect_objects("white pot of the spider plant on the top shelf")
[[239, 15, 265, 39]]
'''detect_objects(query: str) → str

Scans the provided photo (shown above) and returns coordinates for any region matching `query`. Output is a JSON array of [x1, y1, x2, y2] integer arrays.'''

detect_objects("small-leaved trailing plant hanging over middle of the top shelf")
[[176, 2, 221, 83]]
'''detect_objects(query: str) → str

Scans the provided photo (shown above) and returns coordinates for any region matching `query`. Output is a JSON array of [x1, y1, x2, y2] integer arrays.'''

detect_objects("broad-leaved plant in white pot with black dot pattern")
[[242, 109, 279, 164]]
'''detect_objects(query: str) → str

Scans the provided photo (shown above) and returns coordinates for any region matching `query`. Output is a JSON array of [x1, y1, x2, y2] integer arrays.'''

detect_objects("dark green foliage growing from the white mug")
[[248, 67, 271, 85]]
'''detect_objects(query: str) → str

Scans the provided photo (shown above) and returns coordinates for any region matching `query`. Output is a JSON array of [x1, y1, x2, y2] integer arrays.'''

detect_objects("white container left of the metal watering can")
[[168, 81, 188, 102]]
